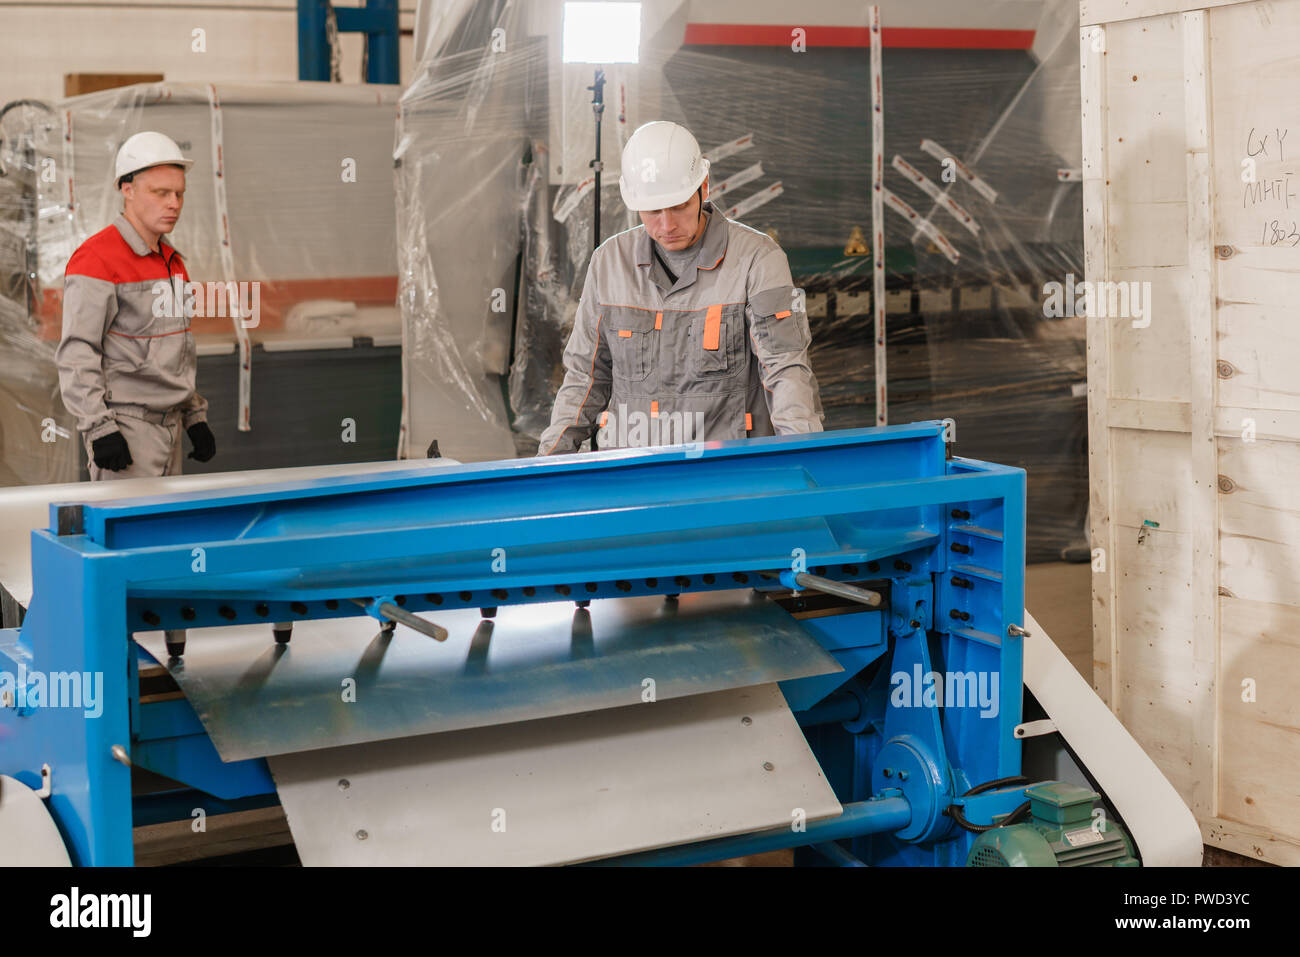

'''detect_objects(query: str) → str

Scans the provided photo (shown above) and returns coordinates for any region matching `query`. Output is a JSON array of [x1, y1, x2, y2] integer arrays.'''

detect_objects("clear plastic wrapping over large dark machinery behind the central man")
[[398, 0, 1087, 560]]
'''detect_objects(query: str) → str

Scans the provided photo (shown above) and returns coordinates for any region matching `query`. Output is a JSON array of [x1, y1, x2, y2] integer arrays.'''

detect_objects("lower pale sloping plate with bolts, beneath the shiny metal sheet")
[[270, 684, 842, 866]]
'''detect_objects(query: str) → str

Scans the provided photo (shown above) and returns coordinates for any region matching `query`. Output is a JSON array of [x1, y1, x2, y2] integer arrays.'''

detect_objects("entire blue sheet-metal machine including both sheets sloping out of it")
[[0, 423, 1196, 865]]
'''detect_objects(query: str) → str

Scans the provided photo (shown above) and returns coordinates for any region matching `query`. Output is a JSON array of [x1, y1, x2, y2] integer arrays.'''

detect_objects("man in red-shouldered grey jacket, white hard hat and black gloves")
[[55, 133, 216, 654]]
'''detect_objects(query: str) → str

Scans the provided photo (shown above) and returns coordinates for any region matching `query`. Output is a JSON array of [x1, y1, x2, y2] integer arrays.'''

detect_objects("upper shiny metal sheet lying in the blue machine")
[[135, 589, 841, 761]]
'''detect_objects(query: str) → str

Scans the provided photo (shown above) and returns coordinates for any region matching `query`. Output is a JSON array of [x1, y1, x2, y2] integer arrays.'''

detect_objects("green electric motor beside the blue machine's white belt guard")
[[966, 781, 1138, 867]]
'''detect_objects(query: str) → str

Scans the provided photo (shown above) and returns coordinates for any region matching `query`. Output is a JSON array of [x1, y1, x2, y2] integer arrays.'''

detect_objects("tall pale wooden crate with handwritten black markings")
[[1079, 0, 1300, 865]]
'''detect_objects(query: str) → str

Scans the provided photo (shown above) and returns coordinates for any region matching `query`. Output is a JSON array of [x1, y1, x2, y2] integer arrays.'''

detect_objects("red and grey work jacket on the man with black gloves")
[[55, 215, 208, 439]]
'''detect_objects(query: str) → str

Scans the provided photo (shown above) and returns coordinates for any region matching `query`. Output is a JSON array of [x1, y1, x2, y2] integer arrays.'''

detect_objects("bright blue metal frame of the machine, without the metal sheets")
[[0, 423, 1027, 865]]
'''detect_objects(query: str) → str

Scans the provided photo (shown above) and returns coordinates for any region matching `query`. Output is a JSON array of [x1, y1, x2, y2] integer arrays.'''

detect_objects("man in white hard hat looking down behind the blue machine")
[[538, 121, 823, 455]]
